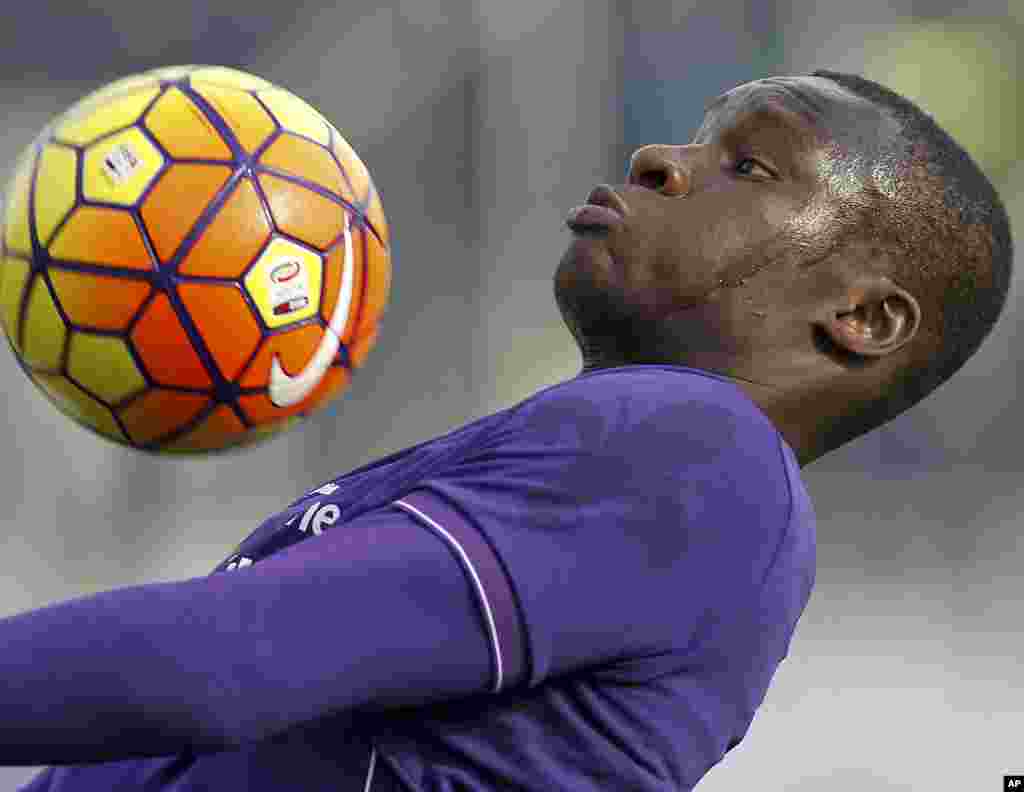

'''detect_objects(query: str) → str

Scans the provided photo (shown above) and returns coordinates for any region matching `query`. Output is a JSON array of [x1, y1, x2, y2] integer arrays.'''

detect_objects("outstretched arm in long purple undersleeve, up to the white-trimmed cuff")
[[0, 499, 511, 764]]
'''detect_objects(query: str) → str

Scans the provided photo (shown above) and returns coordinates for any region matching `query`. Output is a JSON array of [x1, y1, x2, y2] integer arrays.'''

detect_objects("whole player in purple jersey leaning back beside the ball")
[[0, 72, 1012, 792]]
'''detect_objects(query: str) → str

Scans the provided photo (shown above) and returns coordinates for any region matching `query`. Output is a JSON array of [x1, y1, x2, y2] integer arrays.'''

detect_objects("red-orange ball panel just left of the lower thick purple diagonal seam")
[[131, 294, 213, 388]]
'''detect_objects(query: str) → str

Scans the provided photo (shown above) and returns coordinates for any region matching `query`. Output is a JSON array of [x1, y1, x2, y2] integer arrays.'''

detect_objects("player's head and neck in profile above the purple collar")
[[555, 71, 1013, 463]]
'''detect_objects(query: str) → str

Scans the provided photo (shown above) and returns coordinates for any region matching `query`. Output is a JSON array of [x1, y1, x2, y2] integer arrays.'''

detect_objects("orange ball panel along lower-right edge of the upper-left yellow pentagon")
[[141, 163, 231, 261]]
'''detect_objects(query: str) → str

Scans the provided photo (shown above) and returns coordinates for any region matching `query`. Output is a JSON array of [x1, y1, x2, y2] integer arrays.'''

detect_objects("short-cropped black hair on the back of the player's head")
[[811, 70, 1014, 439]]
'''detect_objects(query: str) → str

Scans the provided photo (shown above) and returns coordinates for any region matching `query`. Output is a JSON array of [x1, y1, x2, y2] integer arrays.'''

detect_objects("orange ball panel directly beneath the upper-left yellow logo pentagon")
[[50, 206, 154, 269]]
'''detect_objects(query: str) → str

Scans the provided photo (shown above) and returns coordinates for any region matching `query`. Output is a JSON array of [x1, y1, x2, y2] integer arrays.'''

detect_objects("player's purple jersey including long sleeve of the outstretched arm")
[[0, 365, 815, 792]]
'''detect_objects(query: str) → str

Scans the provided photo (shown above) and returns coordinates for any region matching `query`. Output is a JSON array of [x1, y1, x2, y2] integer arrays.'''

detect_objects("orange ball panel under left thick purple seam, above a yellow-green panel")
[[49, 266, 152, 330]]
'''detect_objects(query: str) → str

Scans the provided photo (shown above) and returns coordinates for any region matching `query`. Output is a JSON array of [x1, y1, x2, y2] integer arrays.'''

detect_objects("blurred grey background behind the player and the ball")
[[0, 0, 1024, 792]]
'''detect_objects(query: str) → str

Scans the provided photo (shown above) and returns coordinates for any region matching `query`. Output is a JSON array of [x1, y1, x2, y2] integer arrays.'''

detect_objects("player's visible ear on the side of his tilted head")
[[817, 276, 921, 358]]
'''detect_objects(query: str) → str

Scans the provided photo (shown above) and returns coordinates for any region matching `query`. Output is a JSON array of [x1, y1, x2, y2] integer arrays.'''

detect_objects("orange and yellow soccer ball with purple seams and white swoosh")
[[0, 66, 391, 453]]
